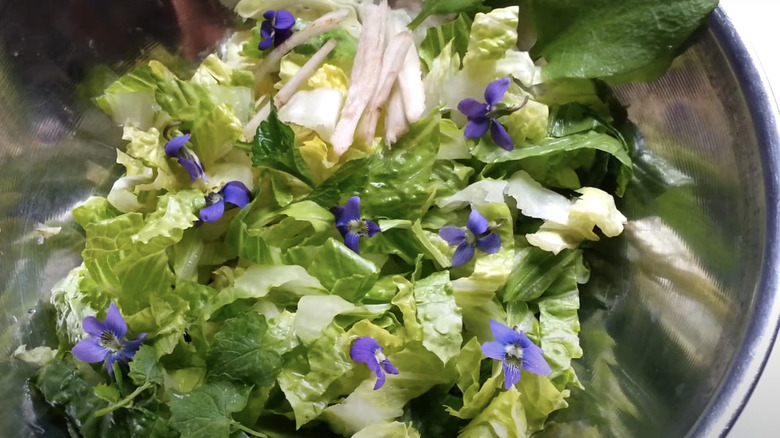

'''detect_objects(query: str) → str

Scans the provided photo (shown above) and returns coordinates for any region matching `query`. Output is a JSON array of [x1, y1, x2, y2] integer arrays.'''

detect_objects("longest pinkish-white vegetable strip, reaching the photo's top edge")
[[331, 1, 390, 157]]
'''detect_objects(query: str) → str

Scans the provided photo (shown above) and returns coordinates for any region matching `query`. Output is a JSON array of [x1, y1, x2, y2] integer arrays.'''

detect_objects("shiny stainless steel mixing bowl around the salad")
[[0, 0, 780, 437]]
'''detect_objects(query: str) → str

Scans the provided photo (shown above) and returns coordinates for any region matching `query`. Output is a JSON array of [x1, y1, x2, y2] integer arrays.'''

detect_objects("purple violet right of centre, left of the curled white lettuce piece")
[[439, 210, 501, 268]]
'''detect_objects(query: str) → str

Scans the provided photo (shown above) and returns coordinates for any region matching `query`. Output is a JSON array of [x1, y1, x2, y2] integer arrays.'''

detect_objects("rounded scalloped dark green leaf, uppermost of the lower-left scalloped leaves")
[[207, 312, 282, 386]]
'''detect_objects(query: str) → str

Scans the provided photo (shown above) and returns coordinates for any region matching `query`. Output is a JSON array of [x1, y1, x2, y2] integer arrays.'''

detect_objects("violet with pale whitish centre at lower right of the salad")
[[482, 319, 550, 389]]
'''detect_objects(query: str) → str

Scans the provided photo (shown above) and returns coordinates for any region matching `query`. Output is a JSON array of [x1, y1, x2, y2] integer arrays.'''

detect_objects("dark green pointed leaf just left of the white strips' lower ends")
[[252, 103, 313, 185]]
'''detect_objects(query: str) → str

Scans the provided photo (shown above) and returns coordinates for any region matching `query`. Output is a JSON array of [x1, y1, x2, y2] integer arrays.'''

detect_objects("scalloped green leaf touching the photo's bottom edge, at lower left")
[[170, 382, 248, 438]]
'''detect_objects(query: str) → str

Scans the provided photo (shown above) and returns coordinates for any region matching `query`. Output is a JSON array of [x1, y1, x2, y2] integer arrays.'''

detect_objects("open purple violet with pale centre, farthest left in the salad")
[[71, 303, 146, 376]]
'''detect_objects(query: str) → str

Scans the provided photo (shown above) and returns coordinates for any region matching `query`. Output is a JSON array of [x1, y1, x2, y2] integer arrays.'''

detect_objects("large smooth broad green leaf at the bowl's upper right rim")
[[526, 0, 718, 79]]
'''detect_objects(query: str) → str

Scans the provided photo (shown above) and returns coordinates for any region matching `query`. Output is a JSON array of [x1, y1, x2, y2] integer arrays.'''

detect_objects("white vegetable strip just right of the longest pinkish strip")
[[358, 30, 414, 144]]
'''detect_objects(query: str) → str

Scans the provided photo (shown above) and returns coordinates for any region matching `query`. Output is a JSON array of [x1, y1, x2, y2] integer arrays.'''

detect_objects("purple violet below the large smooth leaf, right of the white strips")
[[458, 78, 515, 151]]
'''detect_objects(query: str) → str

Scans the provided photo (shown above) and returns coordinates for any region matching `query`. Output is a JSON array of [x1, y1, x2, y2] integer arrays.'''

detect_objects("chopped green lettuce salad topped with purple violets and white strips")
[[14, 0, 717, 438]]
